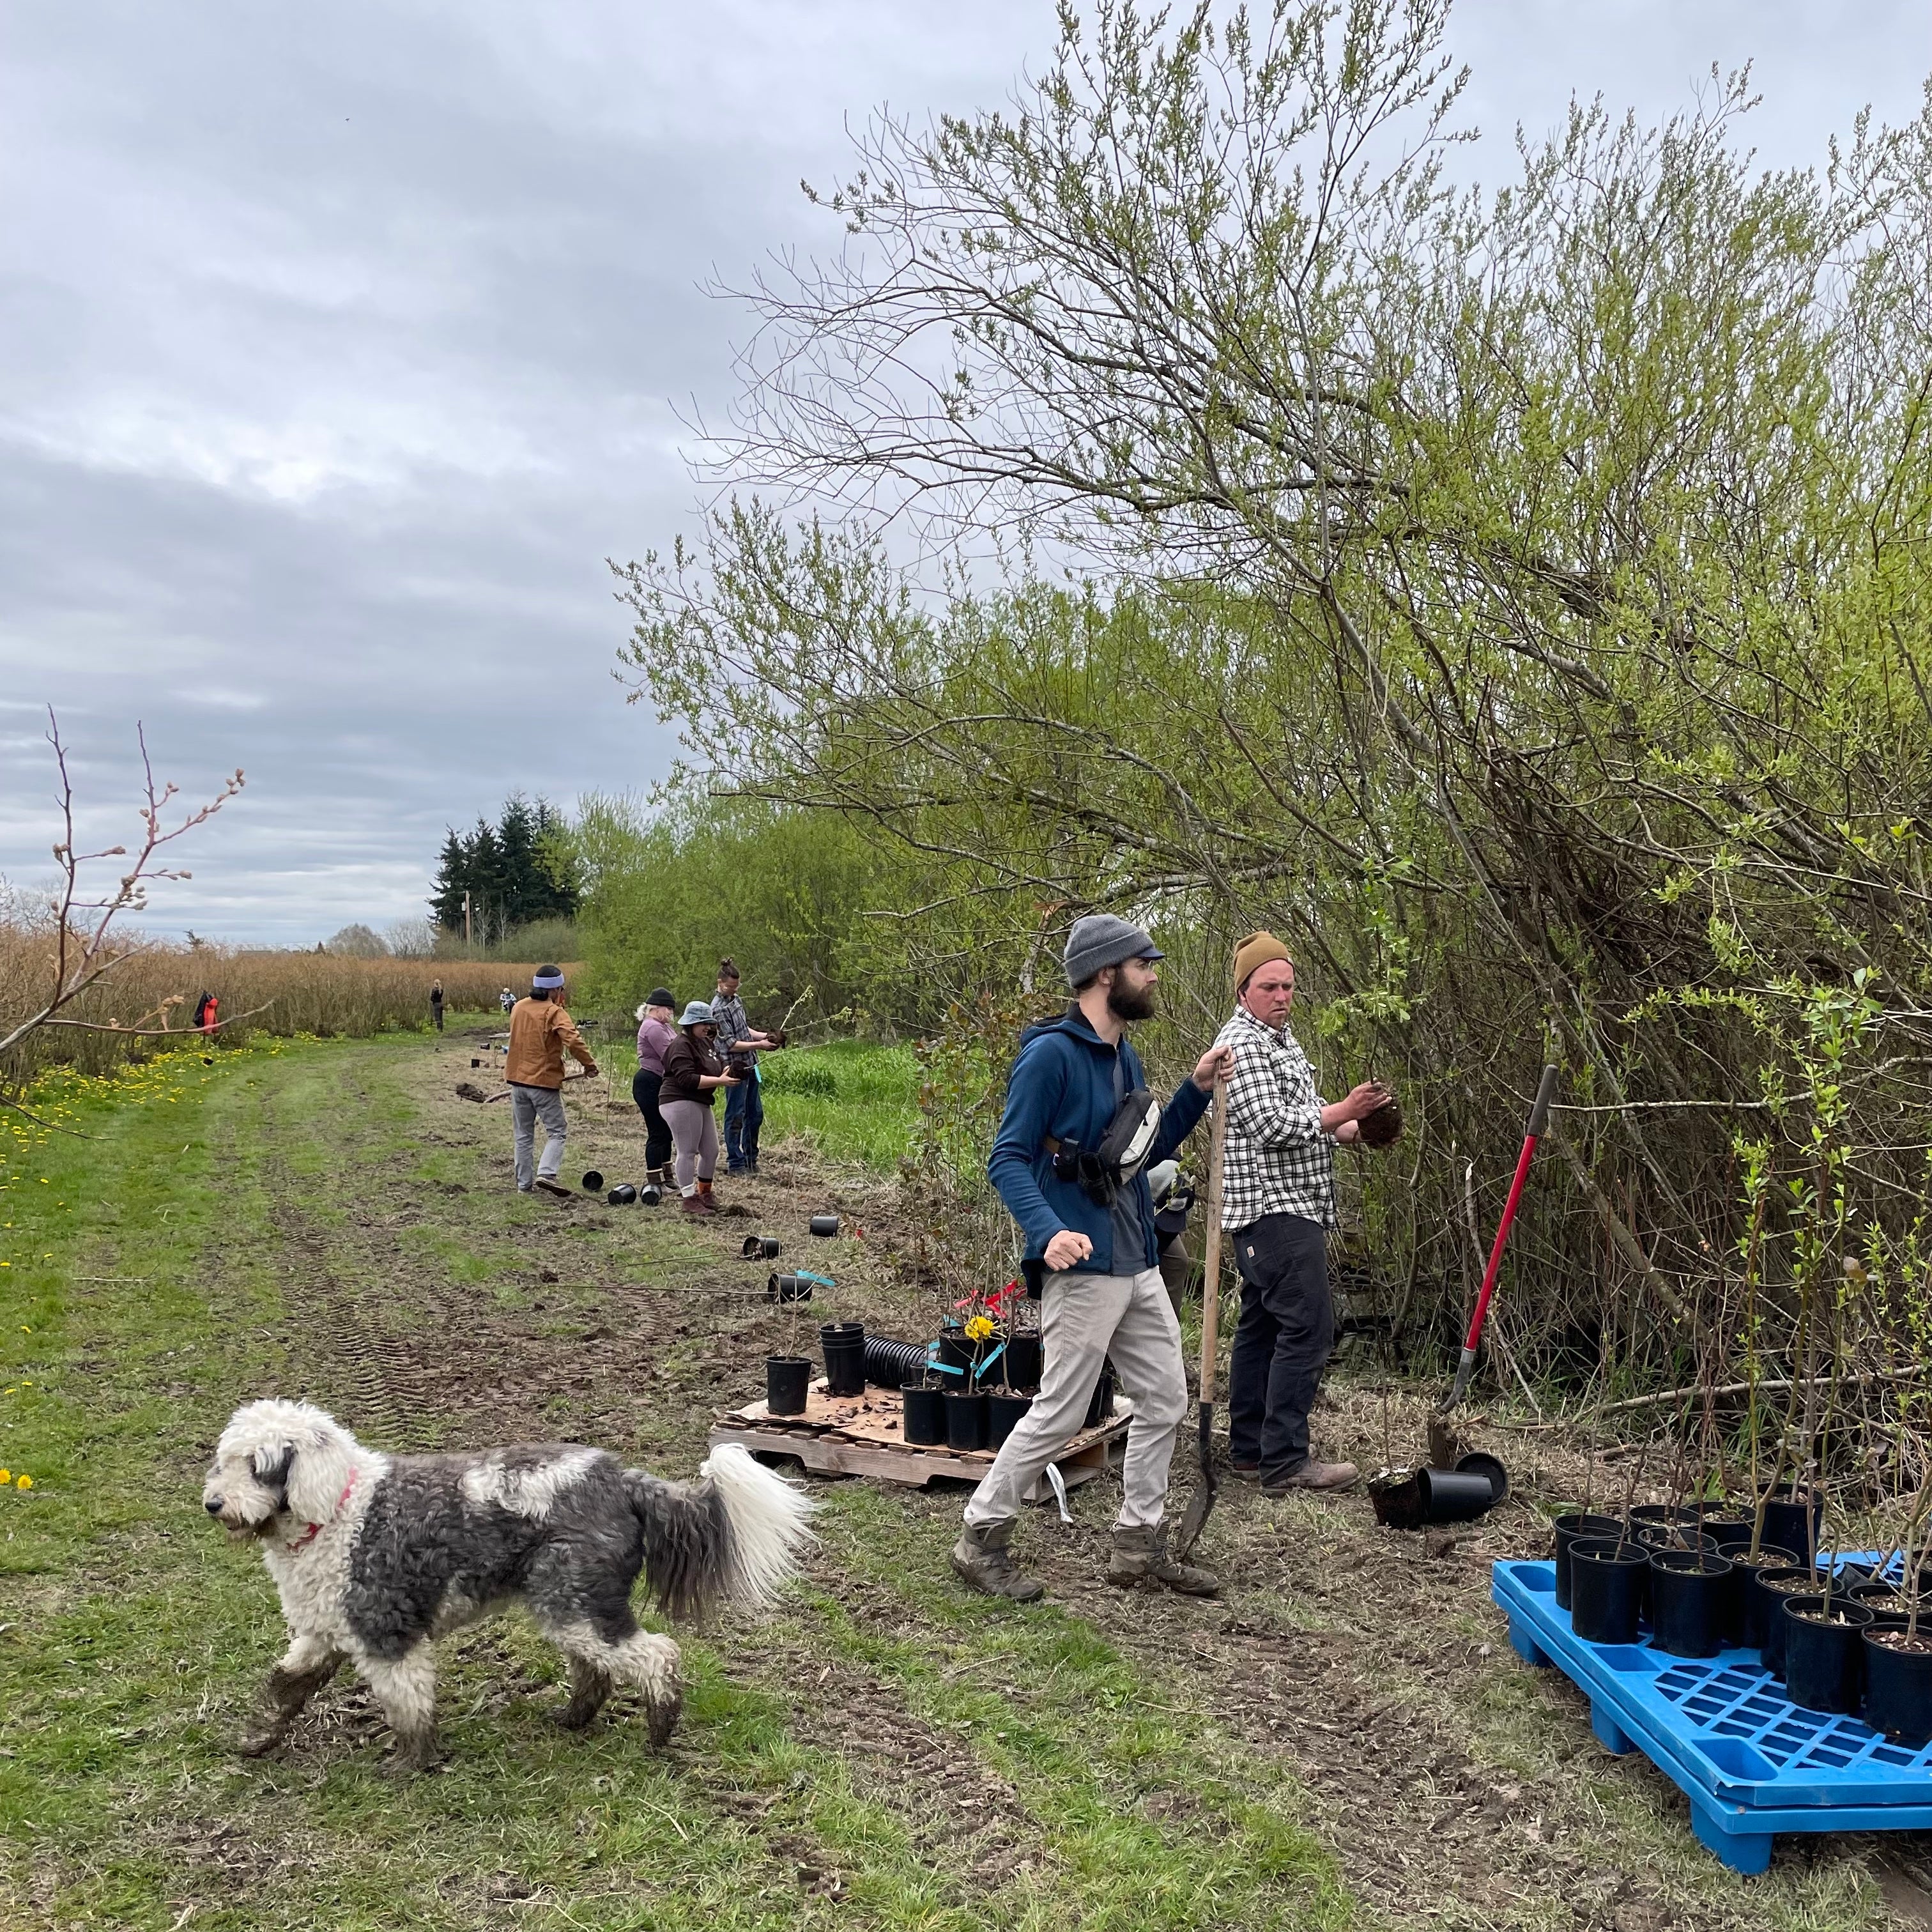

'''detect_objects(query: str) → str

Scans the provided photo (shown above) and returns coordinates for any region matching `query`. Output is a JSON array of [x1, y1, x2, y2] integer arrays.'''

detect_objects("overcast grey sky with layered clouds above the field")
[[0, 0, 1932, 945]]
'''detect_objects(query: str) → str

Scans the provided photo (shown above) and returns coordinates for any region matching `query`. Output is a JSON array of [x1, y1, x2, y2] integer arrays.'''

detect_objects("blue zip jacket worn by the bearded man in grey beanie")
[[985, 1007, 1208, 1275]]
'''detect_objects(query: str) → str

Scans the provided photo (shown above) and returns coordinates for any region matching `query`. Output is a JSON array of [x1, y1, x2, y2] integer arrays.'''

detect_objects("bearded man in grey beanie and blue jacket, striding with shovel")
[[953, 912, 1234, 1604]]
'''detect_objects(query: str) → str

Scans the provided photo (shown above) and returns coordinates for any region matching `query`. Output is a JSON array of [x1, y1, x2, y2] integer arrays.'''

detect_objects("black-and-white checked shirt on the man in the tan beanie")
[[1215, 1007, 1335, 1229]]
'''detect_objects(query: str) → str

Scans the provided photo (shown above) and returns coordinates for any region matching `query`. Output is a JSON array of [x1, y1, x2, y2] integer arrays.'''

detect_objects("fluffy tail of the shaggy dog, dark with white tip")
[[624, 1443, 817, 1617]]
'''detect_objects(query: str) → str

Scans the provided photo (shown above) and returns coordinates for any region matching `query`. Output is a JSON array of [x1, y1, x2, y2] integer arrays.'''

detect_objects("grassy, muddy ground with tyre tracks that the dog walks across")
[[0, 1038, 1911, 1932]]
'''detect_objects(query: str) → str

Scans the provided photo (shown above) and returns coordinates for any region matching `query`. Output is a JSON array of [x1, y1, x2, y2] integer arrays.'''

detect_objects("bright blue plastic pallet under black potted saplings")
[[1490, 1557, 1932, 1872]]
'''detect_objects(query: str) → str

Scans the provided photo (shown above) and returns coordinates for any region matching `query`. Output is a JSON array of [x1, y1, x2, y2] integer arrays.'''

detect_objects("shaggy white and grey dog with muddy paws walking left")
[[201, 1400, 815, 1770]]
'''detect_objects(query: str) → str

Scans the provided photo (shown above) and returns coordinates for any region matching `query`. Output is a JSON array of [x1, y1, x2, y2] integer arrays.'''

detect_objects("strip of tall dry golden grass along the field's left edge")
[[0, 921, 572, 1082]]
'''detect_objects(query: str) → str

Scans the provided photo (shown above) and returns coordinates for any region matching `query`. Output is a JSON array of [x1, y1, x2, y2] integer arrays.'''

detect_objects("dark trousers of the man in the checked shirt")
[[1227, 1213, 1335, 1482]]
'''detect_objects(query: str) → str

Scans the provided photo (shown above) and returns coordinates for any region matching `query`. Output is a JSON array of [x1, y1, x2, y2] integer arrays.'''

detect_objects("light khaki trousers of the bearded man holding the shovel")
[[966, 1268, 1188, 1530]]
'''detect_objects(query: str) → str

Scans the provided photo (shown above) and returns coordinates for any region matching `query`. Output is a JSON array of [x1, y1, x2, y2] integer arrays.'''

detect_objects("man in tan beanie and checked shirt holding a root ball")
[[1215, 933, 1387, 1496]]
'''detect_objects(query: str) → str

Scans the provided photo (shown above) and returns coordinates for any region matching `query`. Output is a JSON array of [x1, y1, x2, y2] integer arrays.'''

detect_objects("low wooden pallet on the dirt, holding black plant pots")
[[711, 1376, 1134, 1503]]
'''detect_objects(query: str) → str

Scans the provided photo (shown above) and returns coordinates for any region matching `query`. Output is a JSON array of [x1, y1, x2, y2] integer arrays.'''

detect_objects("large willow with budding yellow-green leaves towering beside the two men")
[[626, 0, 1932, 1414]]
